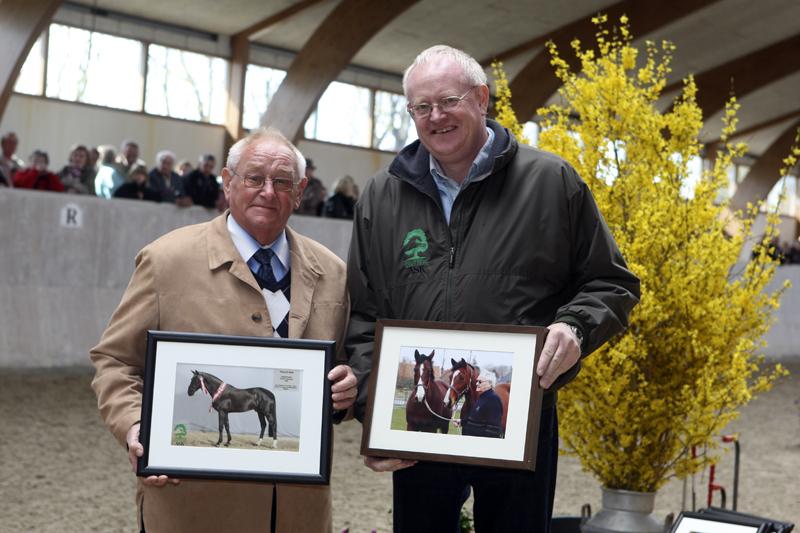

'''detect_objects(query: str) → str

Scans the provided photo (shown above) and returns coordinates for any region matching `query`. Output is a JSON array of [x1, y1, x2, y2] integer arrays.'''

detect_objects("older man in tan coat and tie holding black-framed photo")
[[90, 130, 356, 533]]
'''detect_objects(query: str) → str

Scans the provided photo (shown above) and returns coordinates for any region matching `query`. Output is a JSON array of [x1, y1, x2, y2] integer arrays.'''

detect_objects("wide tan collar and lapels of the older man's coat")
[[206, 210, 325, 338]]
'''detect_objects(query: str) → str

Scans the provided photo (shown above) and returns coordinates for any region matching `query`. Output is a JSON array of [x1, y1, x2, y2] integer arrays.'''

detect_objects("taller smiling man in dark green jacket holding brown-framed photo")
[[346, 46, 639, 532]]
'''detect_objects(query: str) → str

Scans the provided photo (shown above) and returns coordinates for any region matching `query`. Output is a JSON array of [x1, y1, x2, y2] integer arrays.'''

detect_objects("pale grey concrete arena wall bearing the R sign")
[[0, 187, 351, 368]]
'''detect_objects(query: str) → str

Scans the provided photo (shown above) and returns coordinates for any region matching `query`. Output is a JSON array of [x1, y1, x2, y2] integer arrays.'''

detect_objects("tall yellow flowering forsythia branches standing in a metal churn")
[[495, 17, 794, 492]]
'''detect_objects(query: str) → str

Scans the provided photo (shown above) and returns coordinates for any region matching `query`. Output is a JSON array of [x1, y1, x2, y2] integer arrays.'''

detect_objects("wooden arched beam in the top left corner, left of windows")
[[0, 0, 61, 119]]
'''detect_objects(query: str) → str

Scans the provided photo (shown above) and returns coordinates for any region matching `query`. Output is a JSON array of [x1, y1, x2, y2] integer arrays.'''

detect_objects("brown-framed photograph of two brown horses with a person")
[[361, 320, 547, 470]]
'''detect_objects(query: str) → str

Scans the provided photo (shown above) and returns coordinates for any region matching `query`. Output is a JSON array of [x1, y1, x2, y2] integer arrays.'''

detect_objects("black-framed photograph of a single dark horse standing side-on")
[[137, 331, 335, 484]]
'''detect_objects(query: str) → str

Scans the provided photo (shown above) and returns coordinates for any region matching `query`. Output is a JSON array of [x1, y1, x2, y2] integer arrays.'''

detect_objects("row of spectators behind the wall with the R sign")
[[0, 132, 358, 220]]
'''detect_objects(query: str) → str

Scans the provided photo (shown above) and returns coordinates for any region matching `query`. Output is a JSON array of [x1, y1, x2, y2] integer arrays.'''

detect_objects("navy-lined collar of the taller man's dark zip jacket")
[[389, 119, 518, 203]]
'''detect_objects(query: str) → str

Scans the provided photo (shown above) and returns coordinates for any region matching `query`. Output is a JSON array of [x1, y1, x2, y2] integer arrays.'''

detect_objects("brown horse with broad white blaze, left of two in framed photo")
[[406, 350, 453, 433]]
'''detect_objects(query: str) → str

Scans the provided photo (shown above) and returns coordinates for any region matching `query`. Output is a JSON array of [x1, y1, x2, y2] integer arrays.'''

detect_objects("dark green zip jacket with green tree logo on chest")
[[345, 121, 639, 419]]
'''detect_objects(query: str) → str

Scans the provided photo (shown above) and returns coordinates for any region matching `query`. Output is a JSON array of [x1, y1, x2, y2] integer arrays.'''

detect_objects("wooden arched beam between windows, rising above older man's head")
[[263, 0, 418, 141]]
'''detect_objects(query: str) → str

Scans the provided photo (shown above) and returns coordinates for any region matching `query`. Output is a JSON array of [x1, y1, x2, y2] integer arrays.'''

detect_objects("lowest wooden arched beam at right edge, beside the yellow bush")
[[730, 120, 800, 210]]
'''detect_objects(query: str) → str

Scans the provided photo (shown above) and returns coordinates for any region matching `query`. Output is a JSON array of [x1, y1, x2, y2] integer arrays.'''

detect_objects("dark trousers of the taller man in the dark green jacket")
[[393, 405, 558, 533]]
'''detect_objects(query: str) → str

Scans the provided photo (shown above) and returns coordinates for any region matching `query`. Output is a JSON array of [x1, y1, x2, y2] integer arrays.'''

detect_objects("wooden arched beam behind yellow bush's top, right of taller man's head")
[[510, 0, 718, 122]]
